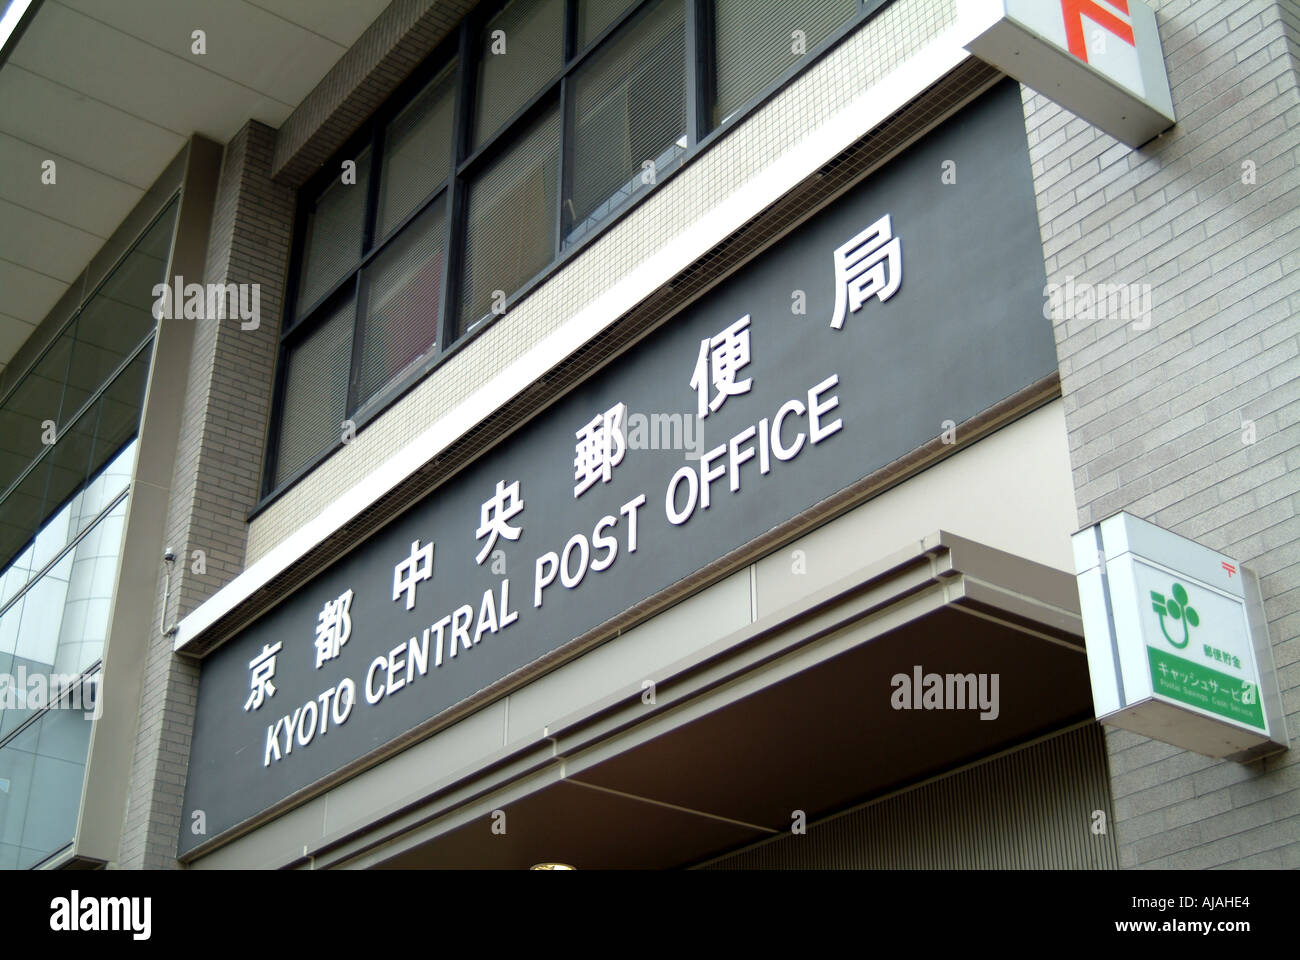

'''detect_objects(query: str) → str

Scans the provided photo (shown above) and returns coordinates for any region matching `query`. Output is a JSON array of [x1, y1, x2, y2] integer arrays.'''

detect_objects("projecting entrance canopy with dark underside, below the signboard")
[[241, 532, 1093, 869]]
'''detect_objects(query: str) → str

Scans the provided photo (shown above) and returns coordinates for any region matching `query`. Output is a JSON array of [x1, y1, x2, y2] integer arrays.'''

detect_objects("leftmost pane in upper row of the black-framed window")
[[298, 150, 371, 316]]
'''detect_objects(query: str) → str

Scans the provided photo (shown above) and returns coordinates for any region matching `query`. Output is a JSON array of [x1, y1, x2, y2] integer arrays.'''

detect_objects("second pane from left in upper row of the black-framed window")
[[376, 61, 456, 237]]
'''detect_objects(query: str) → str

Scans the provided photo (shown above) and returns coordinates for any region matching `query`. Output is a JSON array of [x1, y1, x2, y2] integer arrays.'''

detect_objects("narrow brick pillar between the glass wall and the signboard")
[[120, 122, 294, 869]]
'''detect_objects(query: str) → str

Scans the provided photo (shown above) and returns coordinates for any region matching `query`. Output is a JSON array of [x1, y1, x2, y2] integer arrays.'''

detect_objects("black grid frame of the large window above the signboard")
[[258, 0, 893, 509]]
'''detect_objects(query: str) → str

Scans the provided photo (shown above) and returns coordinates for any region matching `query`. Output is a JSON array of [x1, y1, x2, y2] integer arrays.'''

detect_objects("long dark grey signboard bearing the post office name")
[[179, 82, 1056, 852]]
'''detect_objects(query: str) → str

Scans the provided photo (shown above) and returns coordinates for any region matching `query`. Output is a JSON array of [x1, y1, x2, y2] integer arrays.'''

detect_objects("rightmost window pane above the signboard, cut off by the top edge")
[[712, 0, 858, 126]]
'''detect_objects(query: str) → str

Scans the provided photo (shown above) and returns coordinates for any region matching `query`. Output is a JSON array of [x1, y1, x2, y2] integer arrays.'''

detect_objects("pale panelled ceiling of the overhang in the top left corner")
[[0, 0, 389, 382]]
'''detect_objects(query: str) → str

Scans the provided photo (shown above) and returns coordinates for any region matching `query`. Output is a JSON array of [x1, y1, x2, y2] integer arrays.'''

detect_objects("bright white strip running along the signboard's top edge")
[[173, 21, 971, 650]]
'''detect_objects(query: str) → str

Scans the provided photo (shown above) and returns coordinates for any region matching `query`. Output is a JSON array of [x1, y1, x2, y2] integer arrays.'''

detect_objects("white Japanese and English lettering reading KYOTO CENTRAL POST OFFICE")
[[244, 223, 873, 767]]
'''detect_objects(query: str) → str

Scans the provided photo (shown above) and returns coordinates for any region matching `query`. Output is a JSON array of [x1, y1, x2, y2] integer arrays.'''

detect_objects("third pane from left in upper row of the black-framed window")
[[475, 0, 564, 147]]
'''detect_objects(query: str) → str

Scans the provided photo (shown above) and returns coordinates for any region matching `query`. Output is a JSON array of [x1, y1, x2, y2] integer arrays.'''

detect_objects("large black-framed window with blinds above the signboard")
[[263, 0, 891, 497]]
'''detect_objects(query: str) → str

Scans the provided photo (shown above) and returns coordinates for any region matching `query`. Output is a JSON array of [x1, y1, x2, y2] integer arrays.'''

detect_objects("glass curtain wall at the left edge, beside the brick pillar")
[[0, 198, 177, 869]]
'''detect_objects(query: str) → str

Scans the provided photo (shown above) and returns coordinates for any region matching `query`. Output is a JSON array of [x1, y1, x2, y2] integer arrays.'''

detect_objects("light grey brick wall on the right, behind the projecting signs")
[[1024, 0, 1300, 868]]
